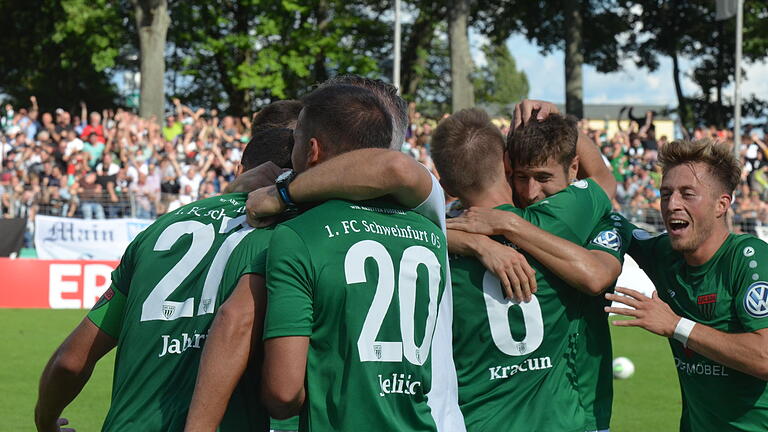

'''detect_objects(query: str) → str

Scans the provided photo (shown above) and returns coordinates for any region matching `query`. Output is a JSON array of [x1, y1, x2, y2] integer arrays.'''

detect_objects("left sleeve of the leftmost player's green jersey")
[[88, 236, 141, 339]]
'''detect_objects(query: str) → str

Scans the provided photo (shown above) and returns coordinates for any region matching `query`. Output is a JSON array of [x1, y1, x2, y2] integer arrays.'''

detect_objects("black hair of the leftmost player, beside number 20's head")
[[240, 128, 293, 171]]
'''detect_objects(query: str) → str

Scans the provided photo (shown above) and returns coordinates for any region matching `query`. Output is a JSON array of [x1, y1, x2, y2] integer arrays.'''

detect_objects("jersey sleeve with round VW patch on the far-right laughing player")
[[733, 237, 768, 331]]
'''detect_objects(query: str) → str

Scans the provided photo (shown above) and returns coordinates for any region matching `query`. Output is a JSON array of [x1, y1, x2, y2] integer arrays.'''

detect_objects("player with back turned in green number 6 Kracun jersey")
[[433, 110, 610, 432]]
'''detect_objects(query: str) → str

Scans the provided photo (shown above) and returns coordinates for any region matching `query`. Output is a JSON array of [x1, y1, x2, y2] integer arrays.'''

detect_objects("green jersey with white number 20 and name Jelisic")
[[264, 200, 464, 431]]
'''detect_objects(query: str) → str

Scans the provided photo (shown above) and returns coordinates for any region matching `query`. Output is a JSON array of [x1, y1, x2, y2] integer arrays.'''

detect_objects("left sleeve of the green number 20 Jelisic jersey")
[[264, 225, 314, 339]]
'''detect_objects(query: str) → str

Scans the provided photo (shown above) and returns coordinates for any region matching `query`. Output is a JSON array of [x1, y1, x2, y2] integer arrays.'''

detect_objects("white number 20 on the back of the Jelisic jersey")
[[344, 240, 441, 366]]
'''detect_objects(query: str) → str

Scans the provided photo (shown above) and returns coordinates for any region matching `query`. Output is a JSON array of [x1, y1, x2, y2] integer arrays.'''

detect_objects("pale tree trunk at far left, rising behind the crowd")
[[133, 0, 171, 124]]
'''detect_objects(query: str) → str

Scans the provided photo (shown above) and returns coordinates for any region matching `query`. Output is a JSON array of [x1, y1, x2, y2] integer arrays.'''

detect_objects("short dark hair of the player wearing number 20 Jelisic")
[[302, 84, 392, 156]]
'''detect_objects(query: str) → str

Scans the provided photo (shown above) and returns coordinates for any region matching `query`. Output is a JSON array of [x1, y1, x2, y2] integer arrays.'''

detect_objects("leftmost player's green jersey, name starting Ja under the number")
[[88, 194, 272, 431]]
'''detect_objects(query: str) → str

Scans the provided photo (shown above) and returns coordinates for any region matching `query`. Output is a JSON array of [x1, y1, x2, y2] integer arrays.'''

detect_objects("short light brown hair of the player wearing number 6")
[[431, 108, 504, 195]]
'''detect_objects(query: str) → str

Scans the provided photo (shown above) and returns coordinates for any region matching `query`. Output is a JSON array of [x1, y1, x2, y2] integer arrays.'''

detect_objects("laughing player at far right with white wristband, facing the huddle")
[[606, 140, 768, 432]]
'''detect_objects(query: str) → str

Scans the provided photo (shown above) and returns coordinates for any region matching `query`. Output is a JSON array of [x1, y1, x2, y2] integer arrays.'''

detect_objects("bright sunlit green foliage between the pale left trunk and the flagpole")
[[169, 0, 391, 114]]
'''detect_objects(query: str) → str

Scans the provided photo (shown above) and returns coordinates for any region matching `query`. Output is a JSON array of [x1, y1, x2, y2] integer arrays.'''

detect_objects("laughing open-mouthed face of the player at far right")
[[661, 162, 731, 253]]
